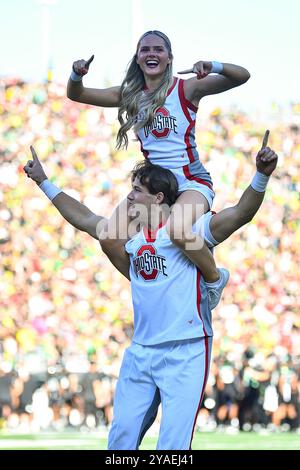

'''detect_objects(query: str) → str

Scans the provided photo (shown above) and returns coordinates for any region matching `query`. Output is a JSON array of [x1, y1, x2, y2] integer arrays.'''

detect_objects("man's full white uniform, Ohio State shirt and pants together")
[[108, 222, 213, 450]]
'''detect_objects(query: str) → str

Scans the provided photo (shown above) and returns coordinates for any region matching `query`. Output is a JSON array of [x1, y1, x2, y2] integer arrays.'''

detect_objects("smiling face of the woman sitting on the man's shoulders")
[[136, 34, 172, 77]]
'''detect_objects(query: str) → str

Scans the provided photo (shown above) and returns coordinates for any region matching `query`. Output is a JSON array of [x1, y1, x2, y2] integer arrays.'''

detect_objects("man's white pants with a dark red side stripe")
[[108, 337, 212, 450]]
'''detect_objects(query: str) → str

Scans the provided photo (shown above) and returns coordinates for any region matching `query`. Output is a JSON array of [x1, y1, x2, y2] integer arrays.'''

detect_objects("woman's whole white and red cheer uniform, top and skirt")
[[137, 77, 214, 207]]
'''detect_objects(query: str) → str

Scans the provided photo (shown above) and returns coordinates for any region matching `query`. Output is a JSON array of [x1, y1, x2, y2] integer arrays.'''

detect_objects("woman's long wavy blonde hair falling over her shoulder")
[[117, 30, 173, 148]]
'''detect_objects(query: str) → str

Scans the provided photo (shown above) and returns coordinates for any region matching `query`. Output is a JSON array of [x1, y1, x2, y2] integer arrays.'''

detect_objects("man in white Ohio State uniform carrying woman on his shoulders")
[[24, 131, 278, 450]]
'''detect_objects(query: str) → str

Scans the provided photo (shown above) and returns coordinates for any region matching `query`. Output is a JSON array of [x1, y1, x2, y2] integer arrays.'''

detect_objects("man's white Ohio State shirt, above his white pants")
[[125, 220, 213, 345]]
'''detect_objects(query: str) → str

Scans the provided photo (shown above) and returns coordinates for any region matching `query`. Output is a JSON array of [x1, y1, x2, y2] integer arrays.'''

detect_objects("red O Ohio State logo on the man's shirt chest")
[[133, 245, 167, 281]]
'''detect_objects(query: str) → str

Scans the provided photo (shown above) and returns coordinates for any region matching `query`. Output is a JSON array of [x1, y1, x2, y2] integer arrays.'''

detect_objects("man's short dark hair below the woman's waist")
[[131, 160, 178, 206]]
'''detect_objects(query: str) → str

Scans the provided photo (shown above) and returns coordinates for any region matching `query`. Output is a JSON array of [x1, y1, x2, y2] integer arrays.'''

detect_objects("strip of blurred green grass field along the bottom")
[[0, 431, 300, 451]]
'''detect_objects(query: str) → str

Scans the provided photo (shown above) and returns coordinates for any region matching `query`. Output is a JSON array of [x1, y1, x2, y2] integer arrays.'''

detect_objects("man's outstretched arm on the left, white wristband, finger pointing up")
[[24, 147, 130, 280]]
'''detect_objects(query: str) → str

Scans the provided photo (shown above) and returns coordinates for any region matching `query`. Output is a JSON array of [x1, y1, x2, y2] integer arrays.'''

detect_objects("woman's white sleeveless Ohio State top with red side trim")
[[137, 77, 211, 181]]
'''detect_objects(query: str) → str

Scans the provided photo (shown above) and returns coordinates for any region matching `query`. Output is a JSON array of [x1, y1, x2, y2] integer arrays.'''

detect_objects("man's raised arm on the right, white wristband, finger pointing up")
[[209, 131, 278, 243]]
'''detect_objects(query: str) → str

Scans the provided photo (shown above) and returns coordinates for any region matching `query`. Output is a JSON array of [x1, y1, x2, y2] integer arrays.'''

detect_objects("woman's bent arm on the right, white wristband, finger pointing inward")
[[178, 60, 250, 105]]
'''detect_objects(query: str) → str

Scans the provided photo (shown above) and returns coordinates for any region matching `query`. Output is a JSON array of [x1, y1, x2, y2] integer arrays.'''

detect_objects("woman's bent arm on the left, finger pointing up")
[[67, 55, 120, 108]]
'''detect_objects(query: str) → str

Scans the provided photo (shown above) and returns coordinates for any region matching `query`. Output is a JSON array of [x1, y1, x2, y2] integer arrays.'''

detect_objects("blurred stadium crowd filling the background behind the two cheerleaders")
[[0, 79, 300, 430]]
